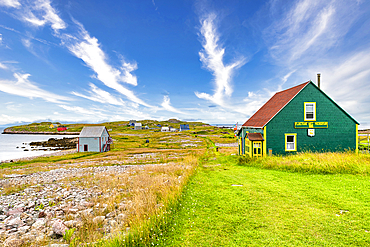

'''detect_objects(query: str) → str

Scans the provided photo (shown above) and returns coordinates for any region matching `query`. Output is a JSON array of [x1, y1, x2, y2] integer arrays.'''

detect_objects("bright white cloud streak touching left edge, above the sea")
[[0, 73, 70, 103]]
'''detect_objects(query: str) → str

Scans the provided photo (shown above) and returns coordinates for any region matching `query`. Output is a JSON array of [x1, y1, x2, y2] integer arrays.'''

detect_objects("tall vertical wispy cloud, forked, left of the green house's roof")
[[195, 13, 246, 106]]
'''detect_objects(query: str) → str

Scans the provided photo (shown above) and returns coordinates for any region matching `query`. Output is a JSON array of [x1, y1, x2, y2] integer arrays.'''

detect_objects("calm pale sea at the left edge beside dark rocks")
[[0, 128, 77, 162]]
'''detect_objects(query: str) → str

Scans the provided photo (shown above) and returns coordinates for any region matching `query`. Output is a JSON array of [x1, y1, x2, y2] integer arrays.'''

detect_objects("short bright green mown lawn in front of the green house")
[[160, 158, 370, 246]]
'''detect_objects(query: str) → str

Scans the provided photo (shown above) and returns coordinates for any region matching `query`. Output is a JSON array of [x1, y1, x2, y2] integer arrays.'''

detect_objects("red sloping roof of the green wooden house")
[[243, 81, 310, 128]]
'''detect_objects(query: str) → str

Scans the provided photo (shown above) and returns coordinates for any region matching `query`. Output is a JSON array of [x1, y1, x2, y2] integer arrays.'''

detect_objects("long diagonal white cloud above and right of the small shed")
[[61, 22, 150, 107]]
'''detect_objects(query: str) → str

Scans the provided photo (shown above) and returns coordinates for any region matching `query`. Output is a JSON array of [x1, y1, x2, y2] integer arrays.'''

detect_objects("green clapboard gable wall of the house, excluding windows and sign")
[[266, 82, 357, 154]]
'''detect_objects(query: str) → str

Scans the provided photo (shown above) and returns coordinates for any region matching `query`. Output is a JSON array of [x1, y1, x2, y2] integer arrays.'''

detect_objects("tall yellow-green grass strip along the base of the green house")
[[236, 152, 370, 175]]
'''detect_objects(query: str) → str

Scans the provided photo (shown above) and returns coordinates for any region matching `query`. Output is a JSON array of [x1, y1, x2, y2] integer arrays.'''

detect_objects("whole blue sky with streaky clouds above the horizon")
[[0, 0, 370, 128]]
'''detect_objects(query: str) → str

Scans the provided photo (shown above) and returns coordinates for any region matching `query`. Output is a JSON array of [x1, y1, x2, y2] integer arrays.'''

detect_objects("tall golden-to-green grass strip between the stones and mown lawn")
[[89, 155, 198, 247]]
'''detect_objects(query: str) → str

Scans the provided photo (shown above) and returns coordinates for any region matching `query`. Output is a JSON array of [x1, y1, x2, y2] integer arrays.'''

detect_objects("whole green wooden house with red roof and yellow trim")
[[237, 81, 359, 157]]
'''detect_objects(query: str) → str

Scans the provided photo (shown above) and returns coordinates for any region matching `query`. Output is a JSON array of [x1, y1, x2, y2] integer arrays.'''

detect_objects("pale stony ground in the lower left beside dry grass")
[[0, 165, 147, 247]]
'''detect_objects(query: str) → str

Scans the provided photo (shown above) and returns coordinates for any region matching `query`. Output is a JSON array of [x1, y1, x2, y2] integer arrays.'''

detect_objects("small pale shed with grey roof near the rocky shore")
[[77, 126, 113, 152]]
